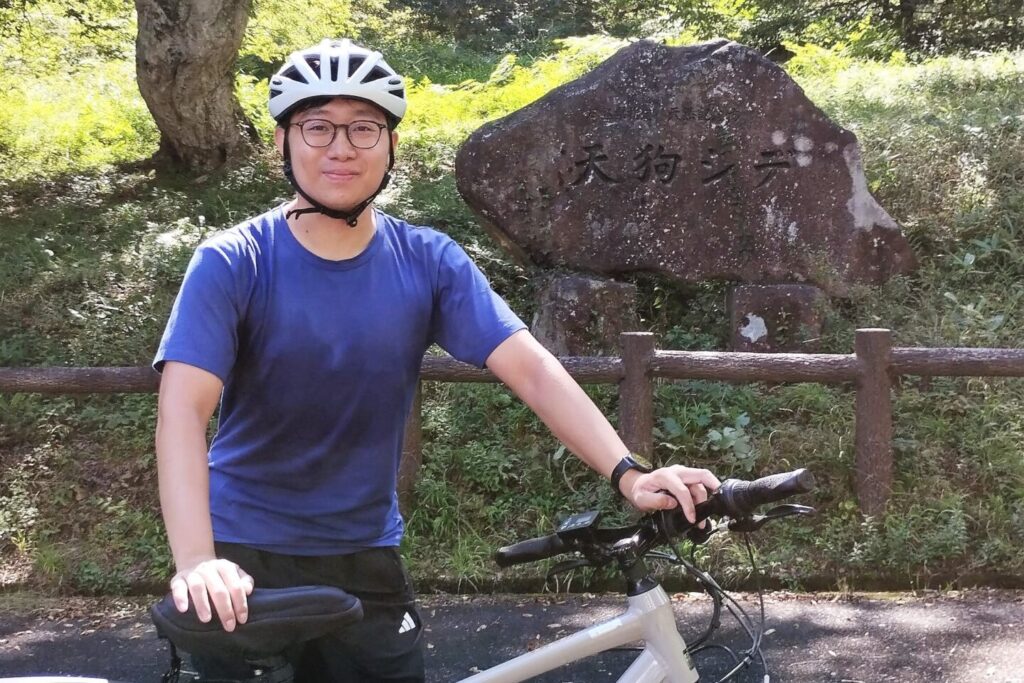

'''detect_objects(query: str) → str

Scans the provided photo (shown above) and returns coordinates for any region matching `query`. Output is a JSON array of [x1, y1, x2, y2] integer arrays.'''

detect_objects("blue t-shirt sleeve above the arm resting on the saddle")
[[153, 237, 243, 382]]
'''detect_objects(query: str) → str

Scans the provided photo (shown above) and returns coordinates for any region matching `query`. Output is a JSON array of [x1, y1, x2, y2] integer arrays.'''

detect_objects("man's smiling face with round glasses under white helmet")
[[274, 97, 398, 209]]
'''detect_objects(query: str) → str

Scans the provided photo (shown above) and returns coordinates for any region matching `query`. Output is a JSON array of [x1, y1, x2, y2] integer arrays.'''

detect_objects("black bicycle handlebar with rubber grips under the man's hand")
[[495, 468, 815, 567]]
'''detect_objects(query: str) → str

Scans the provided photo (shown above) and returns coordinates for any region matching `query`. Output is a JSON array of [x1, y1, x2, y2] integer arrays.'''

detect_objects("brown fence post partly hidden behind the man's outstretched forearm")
[[618, 332, 654, 458]]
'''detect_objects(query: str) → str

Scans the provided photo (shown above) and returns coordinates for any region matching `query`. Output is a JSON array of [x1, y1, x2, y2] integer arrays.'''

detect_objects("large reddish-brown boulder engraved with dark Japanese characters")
[[456, 40, 914, 350]]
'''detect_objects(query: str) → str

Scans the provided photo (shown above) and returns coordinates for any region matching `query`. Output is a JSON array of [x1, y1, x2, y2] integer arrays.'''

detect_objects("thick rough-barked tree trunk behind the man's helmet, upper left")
[[135, 0, 257, 172]]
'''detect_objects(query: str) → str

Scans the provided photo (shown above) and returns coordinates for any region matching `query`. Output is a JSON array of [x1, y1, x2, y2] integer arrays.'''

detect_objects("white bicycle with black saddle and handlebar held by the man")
[[2, 469, 814, 683]]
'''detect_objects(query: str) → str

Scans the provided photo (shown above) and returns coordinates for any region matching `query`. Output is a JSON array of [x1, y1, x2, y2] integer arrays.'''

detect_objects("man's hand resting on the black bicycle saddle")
[[171, 559, 254, 631]]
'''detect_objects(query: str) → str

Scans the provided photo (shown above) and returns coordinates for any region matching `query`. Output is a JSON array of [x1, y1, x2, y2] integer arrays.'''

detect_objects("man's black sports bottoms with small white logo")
[[194, 543, 424, 683]]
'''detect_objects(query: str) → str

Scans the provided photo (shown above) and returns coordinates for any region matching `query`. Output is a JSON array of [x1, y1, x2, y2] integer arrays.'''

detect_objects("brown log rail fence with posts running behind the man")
[[0, 329, 1024, 515]]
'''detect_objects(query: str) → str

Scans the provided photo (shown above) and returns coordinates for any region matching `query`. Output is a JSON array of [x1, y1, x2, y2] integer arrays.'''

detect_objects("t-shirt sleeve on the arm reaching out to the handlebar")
[[431, 242, 526, 368]]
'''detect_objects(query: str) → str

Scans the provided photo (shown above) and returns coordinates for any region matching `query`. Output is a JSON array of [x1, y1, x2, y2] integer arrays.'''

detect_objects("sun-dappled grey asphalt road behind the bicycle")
[[0, 590, 1024, 683]]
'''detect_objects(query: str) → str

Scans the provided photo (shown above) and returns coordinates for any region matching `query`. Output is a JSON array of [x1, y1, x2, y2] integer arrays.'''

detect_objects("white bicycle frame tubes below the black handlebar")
[[461, 586, 699, 683]]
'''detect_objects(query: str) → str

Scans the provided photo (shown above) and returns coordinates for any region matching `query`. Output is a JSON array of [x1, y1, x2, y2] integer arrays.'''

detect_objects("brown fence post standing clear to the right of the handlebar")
[[854, 329, 893, 516]]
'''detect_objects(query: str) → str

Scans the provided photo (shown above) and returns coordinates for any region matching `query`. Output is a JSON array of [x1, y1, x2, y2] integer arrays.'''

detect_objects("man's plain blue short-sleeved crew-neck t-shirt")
[[154, 207, 525, 555]]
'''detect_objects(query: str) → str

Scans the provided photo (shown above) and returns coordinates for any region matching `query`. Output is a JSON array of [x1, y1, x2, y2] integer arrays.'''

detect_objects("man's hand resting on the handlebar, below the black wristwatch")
[[618, 465, 721, 523]]
